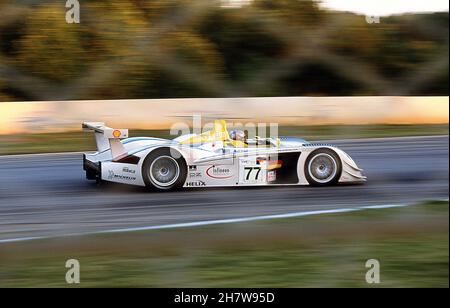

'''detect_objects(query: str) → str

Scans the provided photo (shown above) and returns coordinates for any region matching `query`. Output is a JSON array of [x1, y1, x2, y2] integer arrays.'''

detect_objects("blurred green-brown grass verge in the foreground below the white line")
[[0, 202, 449, 287]]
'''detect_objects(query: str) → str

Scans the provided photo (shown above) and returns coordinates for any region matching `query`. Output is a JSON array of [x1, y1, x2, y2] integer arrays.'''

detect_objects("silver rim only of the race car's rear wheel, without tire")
[[149, 156, 180, 187]]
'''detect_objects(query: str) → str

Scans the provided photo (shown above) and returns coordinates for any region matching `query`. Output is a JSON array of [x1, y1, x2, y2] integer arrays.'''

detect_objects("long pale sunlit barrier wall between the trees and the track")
[[0, 96, 449, 134]]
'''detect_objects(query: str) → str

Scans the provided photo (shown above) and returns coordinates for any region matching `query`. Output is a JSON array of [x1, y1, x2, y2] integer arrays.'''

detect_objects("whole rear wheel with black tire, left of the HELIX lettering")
[[142, 148, 187, 191]]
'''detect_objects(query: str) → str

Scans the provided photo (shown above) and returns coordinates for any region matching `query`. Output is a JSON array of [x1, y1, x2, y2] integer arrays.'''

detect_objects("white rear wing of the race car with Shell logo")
[[82, 122, 128, 159]]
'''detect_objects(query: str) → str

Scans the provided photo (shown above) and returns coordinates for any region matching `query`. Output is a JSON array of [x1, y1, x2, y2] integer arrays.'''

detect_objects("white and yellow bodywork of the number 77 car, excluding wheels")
[[83, 121, 366, 187]]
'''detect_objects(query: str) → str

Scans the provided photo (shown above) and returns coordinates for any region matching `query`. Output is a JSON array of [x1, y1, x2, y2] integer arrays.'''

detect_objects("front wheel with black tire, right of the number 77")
[[305, 149, 342, 186]]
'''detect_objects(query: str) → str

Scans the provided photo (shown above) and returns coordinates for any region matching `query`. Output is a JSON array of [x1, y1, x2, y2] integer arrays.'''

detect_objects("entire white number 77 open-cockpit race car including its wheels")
[[83, 120, 366, 190]]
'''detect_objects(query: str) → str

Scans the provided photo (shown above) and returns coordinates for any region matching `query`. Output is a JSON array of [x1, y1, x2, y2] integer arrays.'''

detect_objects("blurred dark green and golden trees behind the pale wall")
[[0, 0, 448, 101]]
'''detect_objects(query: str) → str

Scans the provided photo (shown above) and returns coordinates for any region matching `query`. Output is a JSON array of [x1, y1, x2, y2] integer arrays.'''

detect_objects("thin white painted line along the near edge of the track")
[[0, 198, 449, 244]]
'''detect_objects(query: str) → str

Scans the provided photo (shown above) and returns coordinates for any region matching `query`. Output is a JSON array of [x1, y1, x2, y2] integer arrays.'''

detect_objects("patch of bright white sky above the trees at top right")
[[322, 0, 449, 16]]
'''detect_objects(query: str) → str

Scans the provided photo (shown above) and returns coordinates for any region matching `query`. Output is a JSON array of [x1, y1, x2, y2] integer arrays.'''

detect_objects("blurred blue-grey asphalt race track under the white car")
[[0, 136, 449, 241]]
